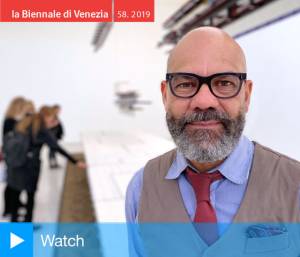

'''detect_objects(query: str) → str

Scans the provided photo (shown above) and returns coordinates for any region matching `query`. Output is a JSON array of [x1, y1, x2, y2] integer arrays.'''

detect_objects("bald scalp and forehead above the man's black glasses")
[[168, 27, 246, 73]]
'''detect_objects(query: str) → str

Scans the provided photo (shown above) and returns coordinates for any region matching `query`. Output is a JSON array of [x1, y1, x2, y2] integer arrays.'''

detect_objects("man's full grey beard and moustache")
[[166, 108, 245, 163]]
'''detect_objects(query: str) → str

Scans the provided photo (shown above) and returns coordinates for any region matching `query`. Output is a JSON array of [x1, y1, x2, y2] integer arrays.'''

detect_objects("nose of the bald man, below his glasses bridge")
[[191, 84, 219, 110]]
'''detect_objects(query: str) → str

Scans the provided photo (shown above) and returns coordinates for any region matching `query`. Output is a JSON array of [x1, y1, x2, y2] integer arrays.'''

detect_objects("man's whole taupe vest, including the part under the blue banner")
[[138, 143, 300, 257]]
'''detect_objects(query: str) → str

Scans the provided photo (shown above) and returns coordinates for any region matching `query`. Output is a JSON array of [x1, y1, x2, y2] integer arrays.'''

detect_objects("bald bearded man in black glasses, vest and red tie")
[[126, 27, 300, 257]]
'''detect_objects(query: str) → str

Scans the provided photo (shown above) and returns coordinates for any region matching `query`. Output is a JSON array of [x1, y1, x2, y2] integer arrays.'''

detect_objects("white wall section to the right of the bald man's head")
[[238, 13, 300, 160]]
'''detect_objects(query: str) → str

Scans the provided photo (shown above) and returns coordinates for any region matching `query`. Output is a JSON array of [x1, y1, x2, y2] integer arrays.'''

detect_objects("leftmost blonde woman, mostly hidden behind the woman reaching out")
[[2, 96, 27, 217]]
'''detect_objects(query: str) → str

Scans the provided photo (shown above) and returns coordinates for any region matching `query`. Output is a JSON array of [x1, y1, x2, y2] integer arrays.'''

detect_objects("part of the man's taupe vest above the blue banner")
[[138, 143, 300, 222]]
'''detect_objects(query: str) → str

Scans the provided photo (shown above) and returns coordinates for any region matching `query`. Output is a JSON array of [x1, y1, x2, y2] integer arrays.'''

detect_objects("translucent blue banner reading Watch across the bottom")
[[0, 223, 300, 257]]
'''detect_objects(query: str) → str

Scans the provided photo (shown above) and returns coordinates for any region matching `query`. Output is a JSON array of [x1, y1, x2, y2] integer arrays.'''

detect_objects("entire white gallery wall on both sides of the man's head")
[[0, 0, 300, 159]]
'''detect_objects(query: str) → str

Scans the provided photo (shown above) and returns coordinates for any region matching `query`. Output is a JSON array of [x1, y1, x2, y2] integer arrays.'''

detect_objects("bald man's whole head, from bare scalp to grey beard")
[[161, 27, 252, 166]]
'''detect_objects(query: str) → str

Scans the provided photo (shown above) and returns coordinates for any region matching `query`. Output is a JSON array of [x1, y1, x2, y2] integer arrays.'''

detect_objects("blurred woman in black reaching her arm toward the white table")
[[7, 106, 85, 222]]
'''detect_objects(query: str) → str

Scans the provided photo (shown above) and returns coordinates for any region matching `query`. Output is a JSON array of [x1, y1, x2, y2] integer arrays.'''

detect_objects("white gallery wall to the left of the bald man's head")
[[0, 0, 183, 142]]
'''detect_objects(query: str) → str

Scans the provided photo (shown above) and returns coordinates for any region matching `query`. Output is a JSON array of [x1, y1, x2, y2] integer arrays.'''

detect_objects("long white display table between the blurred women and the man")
[[83, 131, 174, 222]]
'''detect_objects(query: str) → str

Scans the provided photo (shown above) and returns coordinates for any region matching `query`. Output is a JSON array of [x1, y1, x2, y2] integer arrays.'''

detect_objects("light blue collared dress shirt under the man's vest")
[[125, 136, 254, 256]]
